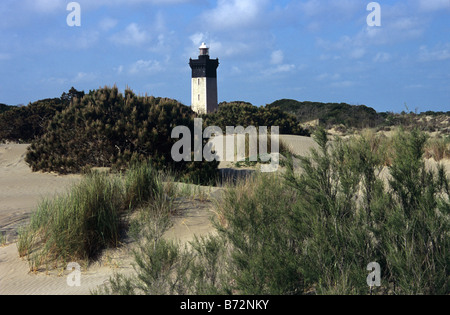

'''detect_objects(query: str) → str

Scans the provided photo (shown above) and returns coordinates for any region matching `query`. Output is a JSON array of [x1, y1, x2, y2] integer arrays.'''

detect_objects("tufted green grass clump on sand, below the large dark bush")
[[18, 163, 162, 271]]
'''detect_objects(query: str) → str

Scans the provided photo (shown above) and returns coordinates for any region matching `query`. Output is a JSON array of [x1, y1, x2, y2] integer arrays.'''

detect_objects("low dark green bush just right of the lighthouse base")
[[205, 102, 309, 136]]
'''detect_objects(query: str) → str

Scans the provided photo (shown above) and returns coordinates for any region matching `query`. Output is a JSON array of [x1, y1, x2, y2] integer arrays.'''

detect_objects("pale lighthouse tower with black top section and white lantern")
[[189, 43, 219, 114]]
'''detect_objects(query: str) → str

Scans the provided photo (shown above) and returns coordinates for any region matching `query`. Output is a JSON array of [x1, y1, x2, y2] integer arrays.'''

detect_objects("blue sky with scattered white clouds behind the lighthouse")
[[0, 0, 450, 112]]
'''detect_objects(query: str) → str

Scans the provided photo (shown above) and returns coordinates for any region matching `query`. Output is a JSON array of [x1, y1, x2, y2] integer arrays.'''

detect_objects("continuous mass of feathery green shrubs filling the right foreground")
[[97, 129, 450, 295]]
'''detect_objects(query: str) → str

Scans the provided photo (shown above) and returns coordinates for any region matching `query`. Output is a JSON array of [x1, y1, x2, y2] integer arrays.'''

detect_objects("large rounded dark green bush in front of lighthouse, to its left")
[[26, 87, 218, 185]]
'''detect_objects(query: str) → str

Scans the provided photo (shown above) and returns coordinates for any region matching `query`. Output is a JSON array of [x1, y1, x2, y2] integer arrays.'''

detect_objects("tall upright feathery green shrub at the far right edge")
[[380, 130, 450, 294]]
